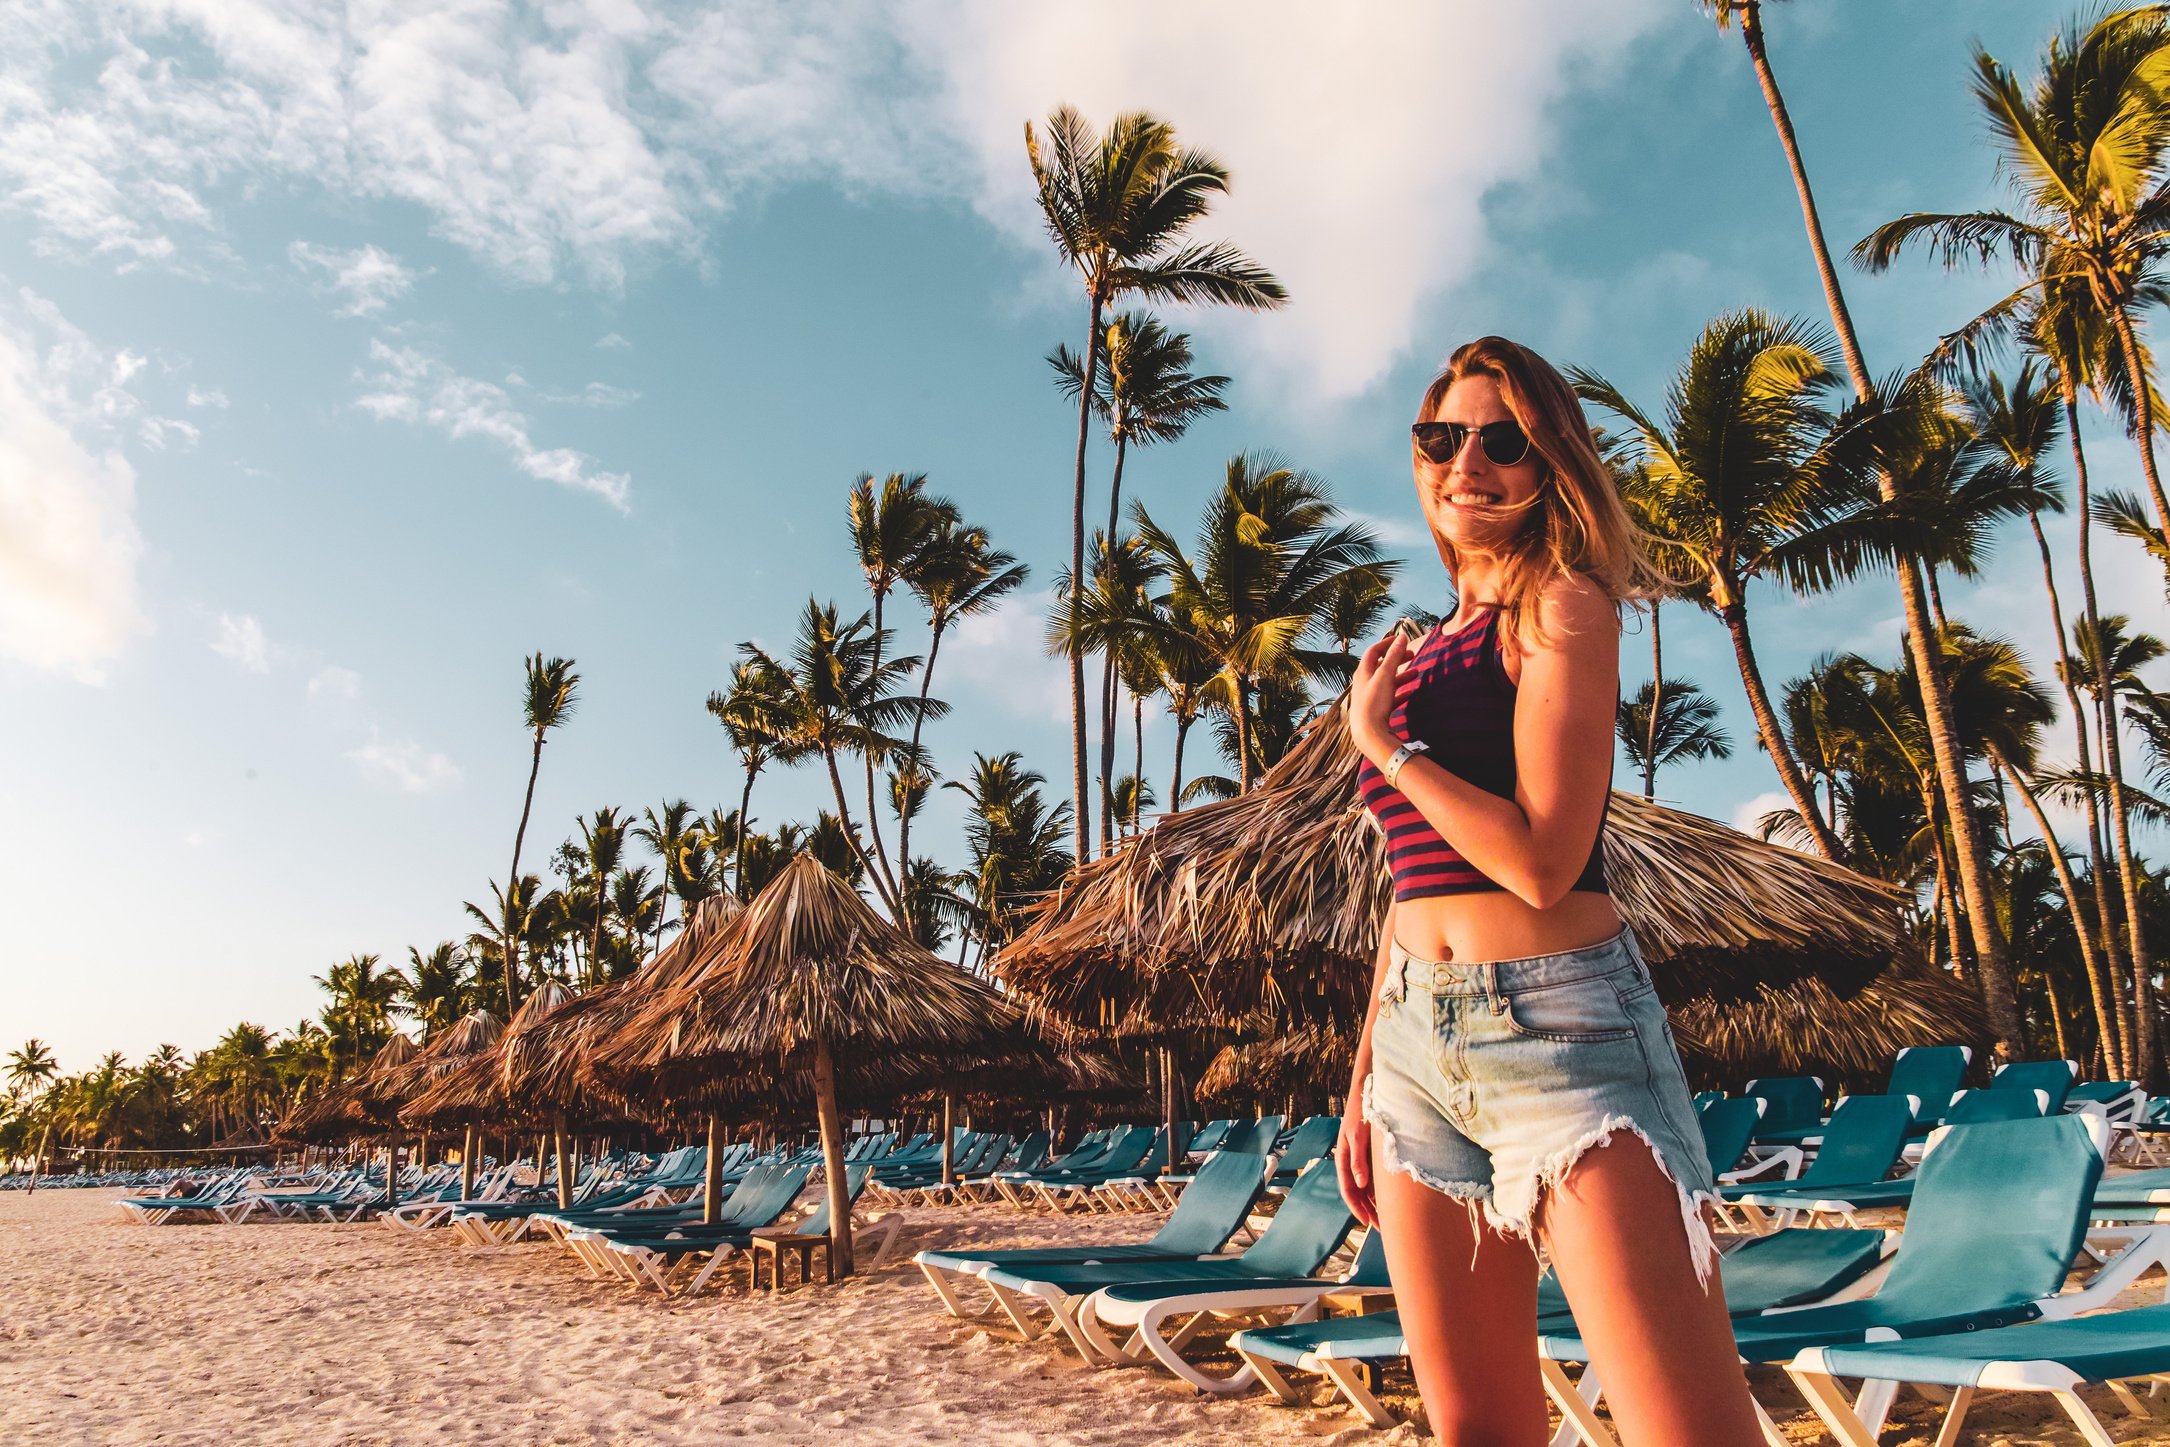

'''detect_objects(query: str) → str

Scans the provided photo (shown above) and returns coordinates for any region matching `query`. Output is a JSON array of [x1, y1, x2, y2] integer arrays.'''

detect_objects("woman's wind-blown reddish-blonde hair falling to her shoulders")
[[1419, 336, 1664, 629]]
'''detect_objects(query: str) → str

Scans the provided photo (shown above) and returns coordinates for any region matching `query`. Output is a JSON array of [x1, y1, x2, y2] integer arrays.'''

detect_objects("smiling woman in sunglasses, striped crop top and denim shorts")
[[1337, 336, 1762, 1447]]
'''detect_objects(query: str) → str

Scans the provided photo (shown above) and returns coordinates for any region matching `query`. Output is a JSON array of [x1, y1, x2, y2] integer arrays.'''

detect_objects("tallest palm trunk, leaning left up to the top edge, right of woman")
[[1738, 0, 2013, 1059]]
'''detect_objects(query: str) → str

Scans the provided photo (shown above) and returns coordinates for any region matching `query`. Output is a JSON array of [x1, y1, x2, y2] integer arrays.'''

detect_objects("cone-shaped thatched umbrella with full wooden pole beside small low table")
[[618, 855, 1018, 1276]]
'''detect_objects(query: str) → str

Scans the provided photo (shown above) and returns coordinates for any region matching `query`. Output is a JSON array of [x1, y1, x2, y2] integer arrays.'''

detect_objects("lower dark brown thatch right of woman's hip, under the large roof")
[[1671, 963, 1990, 1089]]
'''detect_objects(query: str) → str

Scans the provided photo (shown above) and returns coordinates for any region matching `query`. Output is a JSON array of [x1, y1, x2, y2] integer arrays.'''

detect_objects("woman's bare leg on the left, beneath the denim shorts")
[[1371, 1137, 1562, 1447]]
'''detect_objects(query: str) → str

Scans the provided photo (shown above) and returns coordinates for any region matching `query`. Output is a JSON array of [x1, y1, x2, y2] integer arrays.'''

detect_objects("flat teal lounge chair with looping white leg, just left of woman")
[[1081, 1230, 1393, 1397]]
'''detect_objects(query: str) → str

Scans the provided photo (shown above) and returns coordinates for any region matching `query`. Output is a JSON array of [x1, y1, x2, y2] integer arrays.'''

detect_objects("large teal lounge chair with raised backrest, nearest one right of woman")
[[1539, 1115, 2163, 1447]]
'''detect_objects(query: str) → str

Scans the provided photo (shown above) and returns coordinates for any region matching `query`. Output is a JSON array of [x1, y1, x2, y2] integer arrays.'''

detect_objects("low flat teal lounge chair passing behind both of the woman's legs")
[[1230, 1230, 1894, 1427]]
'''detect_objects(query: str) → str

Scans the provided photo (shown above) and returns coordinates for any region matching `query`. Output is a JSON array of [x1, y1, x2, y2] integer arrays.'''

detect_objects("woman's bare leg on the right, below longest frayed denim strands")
[[1545, 1130, 1764, 1447]]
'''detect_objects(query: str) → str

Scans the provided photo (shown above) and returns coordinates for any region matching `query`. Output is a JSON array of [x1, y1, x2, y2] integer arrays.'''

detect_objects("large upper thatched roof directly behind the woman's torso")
[[996, 703, 1905, 1037]]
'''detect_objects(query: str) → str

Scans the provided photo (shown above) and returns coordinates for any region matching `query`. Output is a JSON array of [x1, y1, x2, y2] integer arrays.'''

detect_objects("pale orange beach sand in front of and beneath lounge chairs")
[[0, 1191, 2170, 1447]]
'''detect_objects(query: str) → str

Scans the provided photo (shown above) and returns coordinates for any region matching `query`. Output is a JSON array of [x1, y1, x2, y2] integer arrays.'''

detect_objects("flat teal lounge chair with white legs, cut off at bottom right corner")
[[1786, 1306, 2170, 1447]]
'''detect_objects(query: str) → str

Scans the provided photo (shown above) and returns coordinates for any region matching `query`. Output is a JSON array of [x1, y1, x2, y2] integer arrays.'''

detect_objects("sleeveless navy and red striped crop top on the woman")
[[1356, 607, 1612, 900]]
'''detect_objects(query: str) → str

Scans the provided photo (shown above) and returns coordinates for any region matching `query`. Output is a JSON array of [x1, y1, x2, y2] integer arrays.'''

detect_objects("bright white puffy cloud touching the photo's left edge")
[[0, 291, 150, 681]]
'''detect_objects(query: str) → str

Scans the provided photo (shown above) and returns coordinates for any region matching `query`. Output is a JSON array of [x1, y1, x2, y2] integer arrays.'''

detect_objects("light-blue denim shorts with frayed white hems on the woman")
[[1363, 929, 1716, 1280]]
